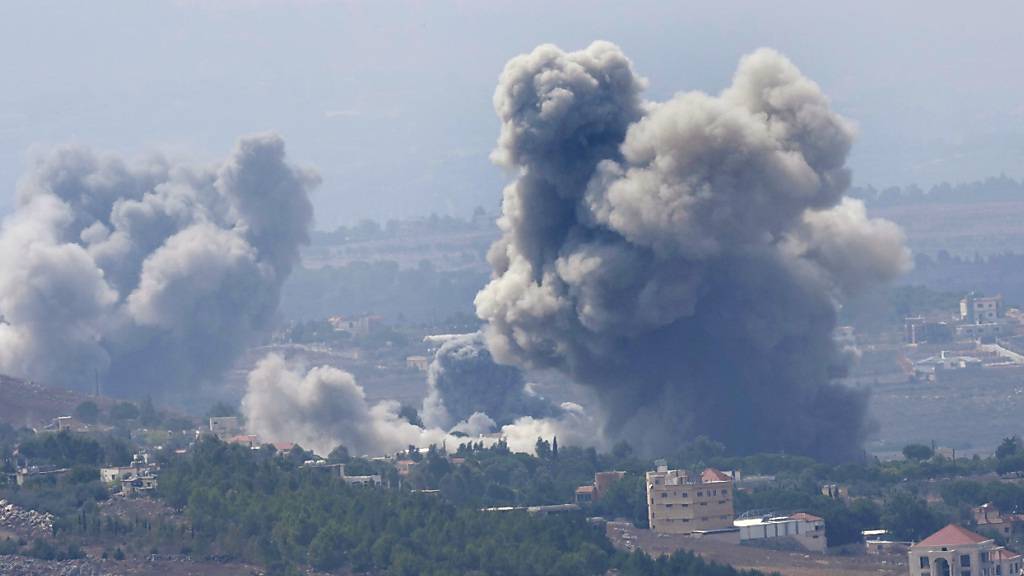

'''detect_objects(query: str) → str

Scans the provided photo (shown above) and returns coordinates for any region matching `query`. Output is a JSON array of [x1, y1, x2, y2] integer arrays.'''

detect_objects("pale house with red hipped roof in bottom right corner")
[[907, 524, 1024, 576]]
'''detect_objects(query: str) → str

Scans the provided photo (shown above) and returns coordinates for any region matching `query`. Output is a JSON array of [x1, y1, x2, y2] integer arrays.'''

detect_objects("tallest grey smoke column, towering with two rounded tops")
[[476, 42, 909, 458]]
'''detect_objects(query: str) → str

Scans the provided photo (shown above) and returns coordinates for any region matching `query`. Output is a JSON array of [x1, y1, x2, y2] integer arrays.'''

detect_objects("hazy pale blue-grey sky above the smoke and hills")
[[0, 0, 1024, 230]]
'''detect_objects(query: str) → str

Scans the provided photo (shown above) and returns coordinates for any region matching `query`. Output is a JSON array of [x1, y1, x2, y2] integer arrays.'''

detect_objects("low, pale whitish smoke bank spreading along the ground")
[[242, 354, 597, 456]]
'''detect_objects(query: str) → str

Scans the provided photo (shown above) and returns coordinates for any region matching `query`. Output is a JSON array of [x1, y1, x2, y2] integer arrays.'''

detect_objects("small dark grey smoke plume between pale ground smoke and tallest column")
[[423, 332, 560, 428]]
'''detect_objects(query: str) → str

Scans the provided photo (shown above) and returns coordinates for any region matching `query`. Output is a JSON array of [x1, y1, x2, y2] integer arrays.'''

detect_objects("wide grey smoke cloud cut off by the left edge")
[[0, 134, 318, 397]]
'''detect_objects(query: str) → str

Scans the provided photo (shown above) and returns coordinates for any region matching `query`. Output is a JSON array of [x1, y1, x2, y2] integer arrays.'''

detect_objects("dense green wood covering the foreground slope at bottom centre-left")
[[160, 440, 770, 576]]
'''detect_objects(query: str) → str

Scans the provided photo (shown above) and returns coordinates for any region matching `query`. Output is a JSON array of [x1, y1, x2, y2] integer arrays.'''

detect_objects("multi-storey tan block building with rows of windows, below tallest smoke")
[[646, 463, 733, 534]]
